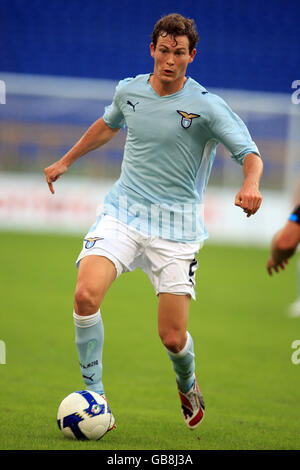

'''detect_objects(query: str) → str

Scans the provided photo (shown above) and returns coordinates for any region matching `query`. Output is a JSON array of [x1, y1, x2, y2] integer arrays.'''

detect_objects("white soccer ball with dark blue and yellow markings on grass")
[[57, 390, 114, 441]]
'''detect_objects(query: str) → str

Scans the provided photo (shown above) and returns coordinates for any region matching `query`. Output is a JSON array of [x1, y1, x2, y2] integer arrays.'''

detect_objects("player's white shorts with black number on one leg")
[[76, 215, 203, 299]]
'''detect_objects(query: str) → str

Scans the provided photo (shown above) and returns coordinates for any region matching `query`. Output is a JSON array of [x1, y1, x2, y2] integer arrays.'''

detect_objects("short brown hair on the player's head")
[[152, 13, 199, 53]]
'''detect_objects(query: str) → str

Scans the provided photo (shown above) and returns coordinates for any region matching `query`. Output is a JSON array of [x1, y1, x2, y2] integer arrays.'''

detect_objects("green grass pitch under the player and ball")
[[0, 232, 300, 450]]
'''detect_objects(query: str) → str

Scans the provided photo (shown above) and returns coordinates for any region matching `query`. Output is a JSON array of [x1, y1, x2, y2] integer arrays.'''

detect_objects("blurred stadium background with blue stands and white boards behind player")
[[0, 0, 300, 243]]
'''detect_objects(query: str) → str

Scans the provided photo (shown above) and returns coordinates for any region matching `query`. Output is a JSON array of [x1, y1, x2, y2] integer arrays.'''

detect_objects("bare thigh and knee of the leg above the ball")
[[75, 255, 117, 310]]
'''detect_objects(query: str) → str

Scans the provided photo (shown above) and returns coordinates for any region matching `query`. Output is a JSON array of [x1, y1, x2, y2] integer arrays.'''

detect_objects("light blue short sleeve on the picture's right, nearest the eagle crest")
[[206, 96, 260, 165]]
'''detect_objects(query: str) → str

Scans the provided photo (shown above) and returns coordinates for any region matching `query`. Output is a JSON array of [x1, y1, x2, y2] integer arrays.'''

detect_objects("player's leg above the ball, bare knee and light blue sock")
[[74, 255, 116, 394]]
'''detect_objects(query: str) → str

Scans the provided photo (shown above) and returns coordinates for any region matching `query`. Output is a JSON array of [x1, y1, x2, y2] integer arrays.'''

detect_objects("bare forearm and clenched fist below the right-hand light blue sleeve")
[[235, 153, 263, 217]]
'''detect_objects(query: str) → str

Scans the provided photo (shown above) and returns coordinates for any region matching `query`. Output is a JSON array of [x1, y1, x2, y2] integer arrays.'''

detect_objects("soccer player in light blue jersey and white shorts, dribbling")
[[44, 14, 263, 429]]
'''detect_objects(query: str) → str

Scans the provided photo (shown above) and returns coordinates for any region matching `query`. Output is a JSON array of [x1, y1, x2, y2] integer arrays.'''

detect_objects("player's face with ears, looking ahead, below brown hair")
[[150, 35, 196, 84]]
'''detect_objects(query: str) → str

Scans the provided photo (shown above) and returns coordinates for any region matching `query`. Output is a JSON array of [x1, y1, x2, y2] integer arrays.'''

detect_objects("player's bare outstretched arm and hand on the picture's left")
[[44, 117, 120, 194]]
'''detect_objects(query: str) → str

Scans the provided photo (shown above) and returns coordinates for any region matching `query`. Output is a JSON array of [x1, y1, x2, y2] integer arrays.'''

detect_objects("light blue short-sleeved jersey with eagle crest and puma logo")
[[103, 74, 259, 242]]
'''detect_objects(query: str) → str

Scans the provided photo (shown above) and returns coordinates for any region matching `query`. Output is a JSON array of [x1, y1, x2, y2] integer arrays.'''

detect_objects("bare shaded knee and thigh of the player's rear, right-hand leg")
[[158, 292, 191, 350]]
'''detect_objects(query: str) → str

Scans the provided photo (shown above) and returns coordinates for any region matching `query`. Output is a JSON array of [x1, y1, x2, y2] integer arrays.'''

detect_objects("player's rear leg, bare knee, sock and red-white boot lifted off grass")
[[158, 293, 205, 429]]
